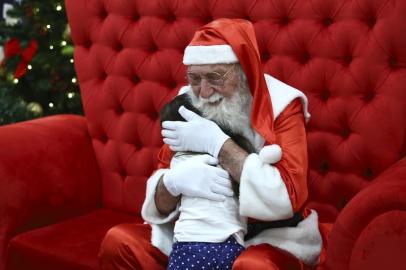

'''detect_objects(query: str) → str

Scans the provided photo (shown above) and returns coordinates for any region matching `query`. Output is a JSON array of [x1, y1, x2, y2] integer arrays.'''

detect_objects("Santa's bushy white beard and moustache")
[[187, 82, 255, 148]]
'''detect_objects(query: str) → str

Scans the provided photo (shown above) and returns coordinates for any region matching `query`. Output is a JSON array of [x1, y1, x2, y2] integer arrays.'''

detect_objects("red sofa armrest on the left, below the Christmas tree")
[[0, 115, 101, 261]]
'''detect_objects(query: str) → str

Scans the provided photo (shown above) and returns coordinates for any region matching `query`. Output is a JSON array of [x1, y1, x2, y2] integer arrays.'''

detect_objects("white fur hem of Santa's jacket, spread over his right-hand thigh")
[[245, 210, 323, 265]]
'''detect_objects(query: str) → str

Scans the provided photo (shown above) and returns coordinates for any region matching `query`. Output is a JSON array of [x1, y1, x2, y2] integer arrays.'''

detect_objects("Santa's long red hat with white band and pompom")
[[183, 18, 281, 163]]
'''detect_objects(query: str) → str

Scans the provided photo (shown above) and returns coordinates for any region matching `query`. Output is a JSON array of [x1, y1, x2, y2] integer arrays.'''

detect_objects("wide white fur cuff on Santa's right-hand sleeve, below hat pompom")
[[240, 153, 293, 221]]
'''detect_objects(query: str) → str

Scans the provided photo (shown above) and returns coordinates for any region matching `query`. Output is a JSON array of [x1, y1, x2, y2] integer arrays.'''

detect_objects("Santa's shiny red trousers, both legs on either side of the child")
[[99, 224, 318, 270]]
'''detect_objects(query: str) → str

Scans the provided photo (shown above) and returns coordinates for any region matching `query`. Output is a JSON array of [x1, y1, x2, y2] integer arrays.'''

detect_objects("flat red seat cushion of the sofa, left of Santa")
[[7, 209, 142, 270]]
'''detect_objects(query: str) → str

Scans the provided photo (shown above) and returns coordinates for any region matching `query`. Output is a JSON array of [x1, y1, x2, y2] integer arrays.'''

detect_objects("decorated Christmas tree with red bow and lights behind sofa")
[[0, 0, 82, 125]]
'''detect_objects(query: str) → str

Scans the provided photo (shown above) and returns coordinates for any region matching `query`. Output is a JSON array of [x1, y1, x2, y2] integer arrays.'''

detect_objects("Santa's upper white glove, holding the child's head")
[[162, 106, 230, 158]]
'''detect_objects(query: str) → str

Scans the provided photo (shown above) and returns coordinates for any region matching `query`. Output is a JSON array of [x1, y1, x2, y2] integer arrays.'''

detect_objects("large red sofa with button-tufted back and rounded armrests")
[[0, 0, 406, 270]]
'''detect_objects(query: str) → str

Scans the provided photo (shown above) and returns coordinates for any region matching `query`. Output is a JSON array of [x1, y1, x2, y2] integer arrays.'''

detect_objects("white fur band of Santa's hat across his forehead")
[[183, 45, 238, 65]]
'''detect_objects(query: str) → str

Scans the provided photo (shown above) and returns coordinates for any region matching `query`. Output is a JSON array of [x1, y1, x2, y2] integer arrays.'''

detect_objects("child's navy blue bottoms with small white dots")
[[168, 236, 244, 270]]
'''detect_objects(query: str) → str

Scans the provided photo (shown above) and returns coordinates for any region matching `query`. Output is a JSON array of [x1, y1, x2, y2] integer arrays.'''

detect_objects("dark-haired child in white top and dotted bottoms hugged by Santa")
[[160, 94, 255, 269]]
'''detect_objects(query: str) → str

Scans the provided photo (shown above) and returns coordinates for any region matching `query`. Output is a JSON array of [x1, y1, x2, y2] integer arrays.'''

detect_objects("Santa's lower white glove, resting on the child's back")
[[163, 155, 234, 201]]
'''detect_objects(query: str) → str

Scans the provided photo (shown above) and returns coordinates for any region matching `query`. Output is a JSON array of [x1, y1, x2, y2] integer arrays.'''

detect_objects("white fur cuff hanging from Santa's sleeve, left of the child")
[[141, 169, 179, 256]]
